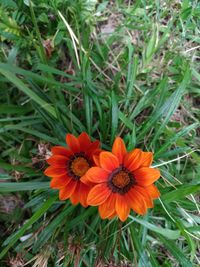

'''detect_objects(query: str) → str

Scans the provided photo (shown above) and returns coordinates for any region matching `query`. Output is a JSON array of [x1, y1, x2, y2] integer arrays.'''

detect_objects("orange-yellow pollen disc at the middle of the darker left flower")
[[71, 157, 90, 177]]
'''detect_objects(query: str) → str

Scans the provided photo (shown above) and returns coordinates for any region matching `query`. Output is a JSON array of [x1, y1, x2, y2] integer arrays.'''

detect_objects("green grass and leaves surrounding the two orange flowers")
[[0, 0, 200, 267]]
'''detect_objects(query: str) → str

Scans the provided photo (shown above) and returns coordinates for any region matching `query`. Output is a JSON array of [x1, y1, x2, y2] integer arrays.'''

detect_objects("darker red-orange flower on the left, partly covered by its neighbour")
[[44, 132, 100, 207]]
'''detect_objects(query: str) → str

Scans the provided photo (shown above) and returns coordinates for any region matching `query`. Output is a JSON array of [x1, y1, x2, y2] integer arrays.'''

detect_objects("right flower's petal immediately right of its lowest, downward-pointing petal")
[[126, 187, 147, 215]]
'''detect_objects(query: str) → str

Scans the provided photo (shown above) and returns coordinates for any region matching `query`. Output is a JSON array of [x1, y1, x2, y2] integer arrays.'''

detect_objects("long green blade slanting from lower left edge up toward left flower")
[[0, 196, 57, 259]]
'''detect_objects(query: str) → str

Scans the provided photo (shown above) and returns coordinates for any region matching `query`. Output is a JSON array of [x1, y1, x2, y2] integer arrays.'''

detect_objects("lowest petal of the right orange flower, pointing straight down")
[[115, 194, 130, 222]]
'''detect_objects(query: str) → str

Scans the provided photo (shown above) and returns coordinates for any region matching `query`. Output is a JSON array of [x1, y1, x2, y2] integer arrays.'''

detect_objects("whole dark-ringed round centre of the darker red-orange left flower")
[[67, 153, 91, 180]]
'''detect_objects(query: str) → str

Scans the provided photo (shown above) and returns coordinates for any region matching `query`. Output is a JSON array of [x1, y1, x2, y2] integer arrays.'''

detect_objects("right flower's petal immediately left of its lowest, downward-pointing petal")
[[99, 193, 116, 219]]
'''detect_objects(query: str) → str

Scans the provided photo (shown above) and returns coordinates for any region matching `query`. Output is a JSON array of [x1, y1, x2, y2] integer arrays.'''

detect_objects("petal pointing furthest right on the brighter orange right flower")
[[133, 167, 160, 186]]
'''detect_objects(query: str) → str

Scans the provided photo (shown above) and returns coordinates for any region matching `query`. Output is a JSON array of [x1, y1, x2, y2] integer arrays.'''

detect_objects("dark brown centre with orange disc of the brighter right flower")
[[108, 165, 135, 195]]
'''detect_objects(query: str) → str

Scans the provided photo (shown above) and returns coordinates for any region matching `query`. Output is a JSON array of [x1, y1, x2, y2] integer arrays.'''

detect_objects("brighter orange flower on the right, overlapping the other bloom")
[[81, 137, 160, 221]]
